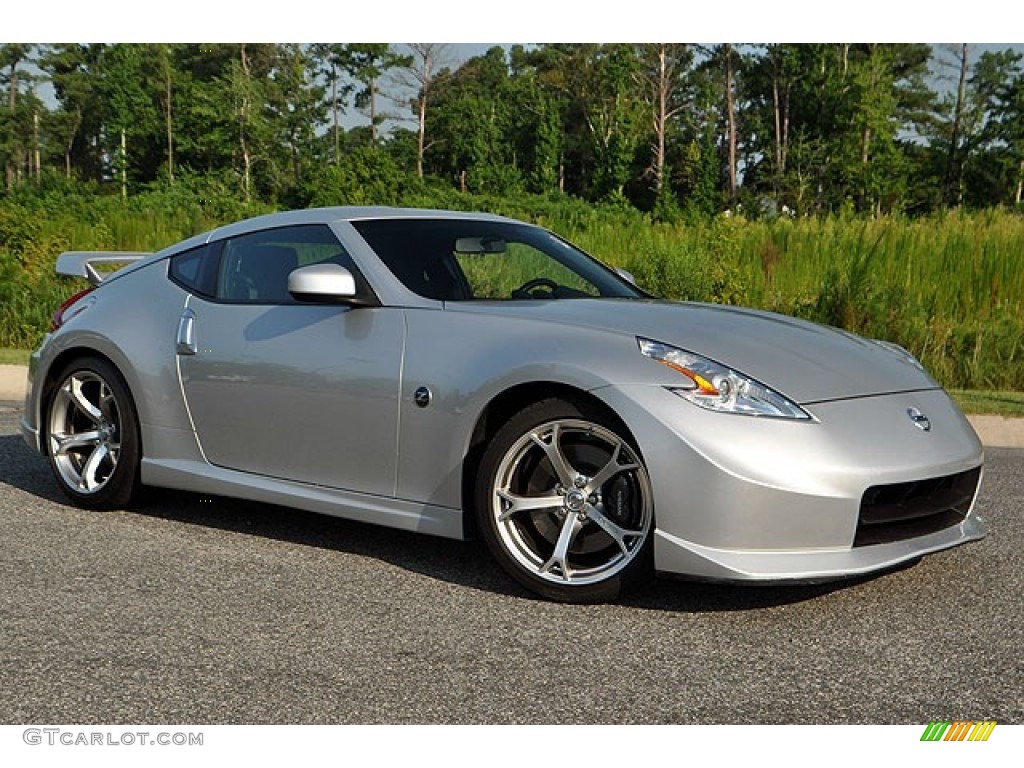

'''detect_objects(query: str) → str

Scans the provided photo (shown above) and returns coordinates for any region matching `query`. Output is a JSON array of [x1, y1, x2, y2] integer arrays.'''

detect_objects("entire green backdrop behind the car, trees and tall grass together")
[[0, 43, 1024, 389]]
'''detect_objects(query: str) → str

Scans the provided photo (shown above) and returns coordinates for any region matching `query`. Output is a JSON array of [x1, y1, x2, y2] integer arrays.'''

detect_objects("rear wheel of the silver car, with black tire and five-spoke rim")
[[44, 357, 141, 510]]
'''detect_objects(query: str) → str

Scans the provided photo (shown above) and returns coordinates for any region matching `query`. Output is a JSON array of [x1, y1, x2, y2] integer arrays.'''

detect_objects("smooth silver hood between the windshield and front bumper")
[[445, 299, 938, 403]]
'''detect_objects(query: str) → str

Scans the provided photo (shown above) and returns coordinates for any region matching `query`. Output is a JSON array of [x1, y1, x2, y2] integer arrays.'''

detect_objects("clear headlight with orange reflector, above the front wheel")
[[637, 338, 811, 419]]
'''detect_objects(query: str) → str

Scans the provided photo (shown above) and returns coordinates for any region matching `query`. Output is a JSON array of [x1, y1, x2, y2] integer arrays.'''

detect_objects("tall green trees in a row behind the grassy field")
[[0, 43, 1024, 218]]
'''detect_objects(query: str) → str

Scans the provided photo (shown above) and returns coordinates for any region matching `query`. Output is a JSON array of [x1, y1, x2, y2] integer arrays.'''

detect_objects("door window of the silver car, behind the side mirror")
[[216, 224, 359, 304]]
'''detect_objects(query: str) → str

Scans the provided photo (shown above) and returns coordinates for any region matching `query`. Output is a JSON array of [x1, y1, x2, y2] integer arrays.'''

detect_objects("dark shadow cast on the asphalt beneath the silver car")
[[0, 435, 897, 613]]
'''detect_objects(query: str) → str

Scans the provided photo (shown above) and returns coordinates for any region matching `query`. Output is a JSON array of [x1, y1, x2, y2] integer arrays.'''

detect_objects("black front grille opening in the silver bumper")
[[853, 467, 981, 547]]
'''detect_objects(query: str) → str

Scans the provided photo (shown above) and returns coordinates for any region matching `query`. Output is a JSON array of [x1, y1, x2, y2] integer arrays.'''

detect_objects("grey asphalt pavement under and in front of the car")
[[0, 402, 1024, 725]]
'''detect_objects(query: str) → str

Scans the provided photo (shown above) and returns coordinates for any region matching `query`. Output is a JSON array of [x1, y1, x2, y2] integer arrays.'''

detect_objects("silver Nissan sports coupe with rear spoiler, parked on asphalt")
[[22, 208, 984, 601]]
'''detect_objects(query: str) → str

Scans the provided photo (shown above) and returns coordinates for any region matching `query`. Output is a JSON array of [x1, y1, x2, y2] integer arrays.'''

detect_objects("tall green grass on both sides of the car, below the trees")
[[0, 195, 1024, 390]]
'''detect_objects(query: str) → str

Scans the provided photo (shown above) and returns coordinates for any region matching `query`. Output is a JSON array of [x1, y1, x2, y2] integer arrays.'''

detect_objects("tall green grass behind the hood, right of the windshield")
[[554, 211, 1024, 390]]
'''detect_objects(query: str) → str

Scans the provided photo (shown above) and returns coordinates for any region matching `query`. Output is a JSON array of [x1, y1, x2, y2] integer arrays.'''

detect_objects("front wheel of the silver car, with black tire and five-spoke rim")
[[475, 399, 654, 603]]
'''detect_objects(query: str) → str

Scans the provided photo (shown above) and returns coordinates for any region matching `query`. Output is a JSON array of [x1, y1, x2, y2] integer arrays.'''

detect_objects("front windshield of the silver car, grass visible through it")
[[352, 219, 644, 301]]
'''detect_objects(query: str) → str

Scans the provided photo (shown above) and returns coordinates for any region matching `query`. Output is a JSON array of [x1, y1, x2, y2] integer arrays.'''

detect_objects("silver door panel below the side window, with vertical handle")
[[179, 297, 406, 496]]
